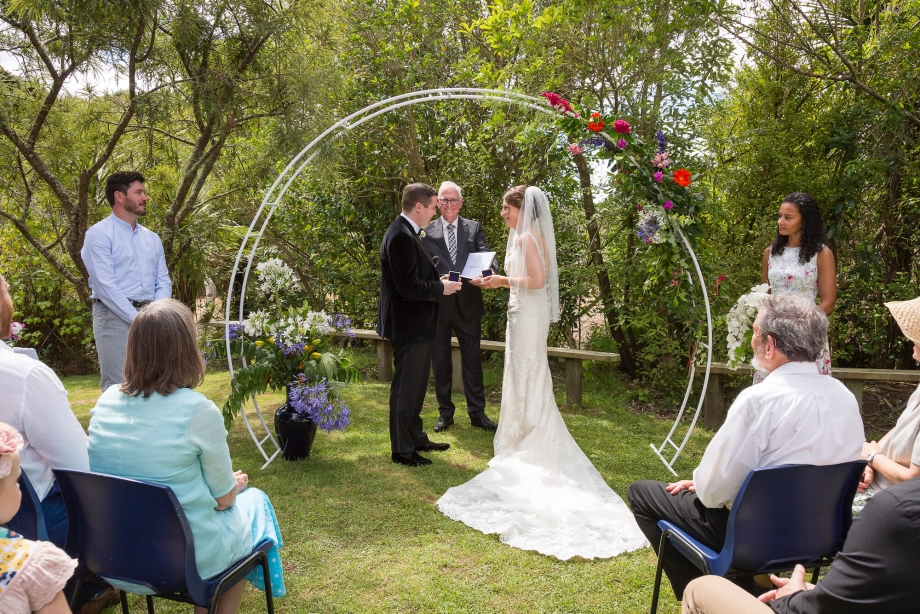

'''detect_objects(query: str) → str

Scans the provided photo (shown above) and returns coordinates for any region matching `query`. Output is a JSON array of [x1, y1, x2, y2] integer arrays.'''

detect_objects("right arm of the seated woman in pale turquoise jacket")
[[186, 399, 239, 510]]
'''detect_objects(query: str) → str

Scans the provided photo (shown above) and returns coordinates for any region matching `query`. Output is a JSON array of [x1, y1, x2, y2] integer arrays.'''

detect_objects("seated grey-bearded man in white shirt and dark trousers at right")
[[627, 293, 864, 599]]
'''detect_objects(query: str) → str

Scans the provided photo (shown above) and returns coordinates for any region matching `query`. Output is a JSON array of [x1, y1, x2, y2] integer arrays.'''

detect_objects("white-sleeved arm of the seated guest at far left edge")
[[22, 363, 89, 471]]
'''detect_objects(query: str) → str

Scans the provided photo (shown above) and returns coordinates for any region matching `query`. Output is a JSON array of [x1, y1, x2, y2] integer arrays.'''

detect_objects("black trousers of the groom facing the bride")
[[390, 341, 431, 454]]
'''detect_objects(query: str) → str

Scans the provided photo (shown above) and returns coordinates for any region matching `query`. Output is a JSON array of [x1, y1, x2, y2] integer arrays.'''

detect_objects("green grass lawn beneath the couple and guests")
[[64, 356, 711, 614]]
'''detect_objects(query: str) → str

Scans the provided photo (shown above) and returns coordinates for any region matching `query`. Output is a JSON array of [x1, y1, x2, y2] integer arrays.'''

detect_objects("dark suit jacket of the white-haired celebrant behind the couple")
[[425, 217, 498, 320]]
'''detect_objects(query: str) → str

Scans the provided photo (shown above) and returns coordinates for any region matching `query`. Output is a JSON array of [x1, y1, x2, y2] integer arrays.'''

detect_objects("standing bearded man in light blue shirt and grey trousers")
[[80, 172, 172, 390]]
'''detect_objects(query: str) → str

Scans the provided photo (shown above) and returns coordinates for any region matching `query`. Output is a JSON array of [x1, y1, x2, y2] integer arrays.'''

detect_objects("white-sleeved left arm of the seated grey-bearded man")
[[693, 388, 766, 508]]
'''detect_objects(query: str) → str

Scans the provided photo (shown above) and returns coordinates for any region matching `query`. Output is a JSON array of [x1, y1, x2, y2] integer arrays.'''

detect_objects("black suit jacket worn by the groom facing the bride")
[[377, 216, 444, 343]]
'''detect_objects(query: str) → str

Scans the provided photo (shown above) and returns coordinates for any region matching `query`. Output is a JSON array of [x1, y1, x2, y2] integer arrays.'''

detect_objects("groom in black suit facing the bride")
[[377, 183, 462, 467]]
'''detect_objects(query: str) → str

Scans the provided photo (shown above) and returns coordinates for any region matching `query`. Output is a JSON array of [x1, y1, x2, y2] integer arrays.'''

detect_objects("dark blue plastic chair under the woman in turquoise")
[[54, 469, 274, 614]]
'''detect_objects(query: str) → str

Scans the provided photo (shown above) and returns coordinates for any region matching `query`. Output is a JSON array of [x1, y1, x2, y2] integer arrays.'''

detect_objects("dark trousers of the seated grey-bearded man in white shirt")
[[626, 480, 728, 600]]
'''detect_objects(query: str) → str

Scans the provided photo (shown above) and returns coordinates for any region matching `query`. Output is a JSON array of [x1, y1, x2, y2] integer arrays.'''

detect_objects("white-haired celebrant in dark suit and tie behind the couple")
[[425, 181, 498, 433]]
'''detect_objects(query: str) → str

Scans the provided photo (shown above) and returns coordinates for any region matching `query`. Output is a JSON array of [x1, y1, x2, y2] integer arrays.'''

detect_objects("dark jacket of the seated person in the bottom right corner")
[[769, 478, 920, 614]]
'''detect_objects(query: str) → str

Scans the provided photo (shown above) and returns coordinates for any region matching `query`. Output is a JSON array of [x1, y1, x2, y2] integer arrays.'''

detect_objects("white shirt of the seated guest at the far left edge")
[[0, 341, 89, 499]]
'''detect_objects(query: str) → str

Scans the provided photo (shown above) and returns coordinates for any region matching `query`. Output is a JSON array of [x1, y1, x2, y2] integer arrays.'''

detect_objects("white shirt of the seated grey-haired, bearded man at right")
[[693, 362, 866, 508]]
